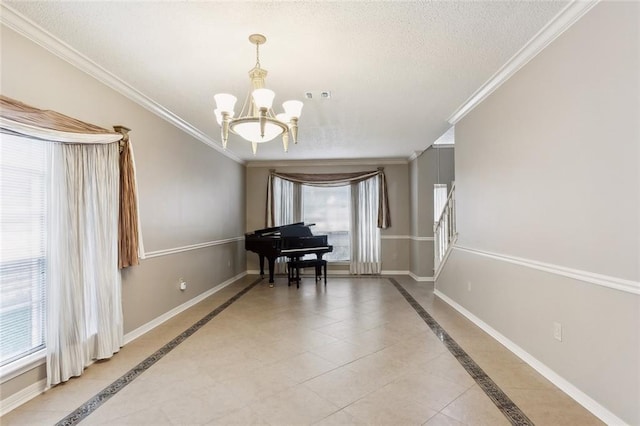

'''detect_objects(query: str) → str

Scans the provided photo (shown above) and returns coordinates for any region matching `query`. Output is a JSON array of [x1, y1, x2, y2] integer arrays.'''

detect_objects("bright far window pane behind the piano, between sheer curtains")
[[302, 185, 351, 262]]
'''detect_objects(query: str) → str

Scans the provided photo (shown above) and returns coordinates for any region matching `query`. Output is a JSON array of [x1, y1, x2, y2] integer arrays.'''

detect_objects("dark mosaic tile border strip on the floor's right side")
[[388, 278, 533, 426]]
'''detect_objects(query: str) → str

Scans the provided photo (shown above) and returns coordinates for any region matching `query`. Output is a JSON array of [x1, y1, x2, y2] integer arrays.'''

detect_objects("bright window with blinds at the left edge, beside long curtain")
[[0, 134, 47, 366]]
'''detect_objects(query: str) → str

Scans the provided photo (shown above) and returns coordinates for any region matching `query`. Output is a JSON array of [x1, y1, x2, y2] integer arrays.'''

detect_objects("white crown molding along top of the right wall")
[[447, 0, 600, 125]]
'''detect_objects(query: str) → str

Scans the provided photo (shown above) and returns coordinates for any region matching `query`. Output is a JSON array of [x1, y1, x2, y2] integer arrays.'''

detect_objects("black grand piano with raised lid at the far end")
[[244, 222, 333, 284]]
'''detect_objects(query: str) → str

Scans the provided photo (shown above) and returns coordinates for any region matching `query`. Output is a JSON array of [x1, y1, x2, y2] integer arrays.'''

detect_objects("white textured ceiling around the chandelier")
[[3, 0, 567, 160]]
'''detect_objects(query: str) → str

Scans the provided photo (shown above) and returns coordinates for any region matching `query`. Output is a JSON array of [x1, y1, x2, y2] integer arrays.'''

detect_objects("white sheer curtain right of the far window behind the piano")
[[349, 177, 382, 275]]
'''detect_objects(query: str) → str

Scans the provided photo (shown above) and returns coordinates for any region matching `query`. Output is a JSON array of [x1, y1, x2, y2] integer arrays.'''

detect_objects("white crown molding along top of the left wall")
[[0, 3, 244, 164]]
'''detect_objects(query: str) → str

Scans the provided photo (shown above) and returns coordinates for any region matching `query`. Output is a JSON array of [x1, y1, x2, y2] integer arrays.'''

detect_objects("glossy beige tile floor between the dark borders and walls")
[[0, 276, 602, 426]]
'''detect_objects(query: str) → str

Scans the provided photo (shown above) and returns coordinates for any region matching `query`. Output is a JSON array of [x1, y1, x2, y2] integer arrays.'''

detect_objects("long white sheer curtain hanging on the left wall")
[[46, 143, 123, 385]]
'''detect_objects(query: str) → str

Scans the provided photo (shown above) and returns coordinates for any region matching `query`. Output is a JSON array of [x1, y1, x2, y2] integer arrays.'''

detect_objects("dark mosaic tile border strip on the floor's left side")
[[56, 278, 262, 426]]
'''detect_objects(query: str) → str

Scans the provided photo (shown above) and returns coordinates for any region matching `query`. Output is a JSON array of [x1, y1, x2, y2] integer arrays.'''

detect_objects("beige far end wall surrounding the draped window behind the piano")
[[246, 161, 410, 273]]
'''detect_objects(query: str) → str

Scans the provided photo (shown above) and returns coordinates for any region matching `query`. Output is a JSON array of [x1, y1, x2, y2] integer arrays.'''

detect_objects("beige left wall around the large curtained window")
[[1, 26, 245, 398]]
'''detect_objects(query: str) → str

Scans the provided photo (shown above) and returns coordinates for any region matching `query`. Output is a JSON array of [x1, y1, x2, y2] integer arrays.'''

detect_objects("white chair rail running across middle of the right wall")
[[456, 244, 640, 295]]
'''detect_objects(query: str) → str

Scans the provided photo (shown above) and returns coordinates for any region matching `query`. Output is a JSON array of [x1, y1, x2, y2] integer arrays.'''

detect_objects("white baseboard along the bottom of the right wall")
[[433, 289, 626, 426]]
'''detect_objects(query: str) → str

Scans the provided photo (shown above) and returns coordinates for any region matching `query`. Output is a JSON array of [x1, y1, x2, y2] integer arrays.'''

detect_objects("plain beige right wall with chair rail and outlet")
[[436, 2, 640, 424]]
